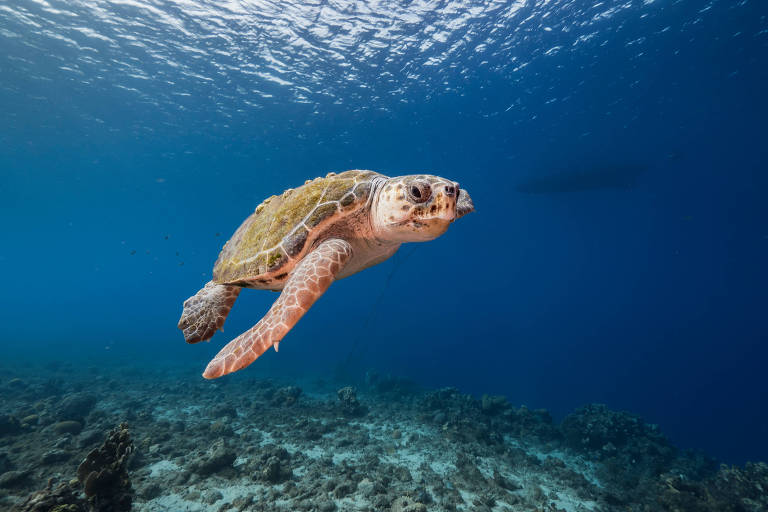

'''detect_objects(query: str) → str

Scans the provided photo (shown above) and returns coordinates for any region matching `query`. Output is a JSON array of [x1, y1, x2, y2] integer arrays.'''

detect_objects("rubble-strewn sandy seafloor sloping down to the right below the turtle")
[[0, 363, 768, 512]]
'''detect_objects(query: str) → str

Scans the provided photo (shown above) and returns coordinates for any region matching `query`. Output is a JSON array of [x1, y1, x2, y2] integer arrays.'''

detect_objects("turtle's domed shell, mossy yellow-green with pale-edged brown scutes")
[[213, 170, 381, 286]]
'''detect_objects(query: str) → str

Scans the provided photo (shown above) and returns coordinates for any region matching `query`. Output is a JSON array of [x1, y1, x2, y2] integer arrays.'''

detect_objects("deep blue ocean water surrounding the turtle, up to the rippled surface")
[[0, 0, 768, 470]]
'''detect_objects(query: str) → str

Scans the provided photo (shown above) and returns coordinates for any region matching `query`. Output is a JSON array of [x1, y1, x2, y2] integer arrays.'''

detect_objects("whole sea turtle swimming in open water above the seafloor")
[[179, 170, 474, 379]]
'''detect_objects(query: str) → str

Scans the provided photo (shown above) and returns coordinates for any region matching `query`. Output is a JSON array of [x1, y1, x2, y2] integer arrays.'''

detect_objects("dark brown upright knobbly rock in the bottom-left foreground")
[[77, 423, 134, 512]]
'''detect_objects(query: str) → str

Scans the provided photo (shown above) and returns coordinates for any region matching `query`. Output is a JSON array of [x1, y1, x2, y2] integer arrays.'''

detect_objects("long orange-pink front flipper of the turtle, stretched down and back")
[[203, 238, 352, 379]]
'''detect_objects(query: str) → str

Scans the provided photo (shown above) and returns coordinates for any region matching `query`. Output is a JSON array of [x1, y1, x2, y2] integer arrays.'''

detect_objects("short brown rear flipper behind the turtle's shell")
[[178, 281, 240, 343]]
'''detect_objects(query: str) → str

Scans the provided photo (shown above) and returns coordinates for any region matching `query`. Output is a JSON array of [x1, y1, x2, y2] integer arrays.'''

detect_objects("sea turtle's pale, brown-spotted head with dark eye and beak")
[[372, 174, 475, 242]]
